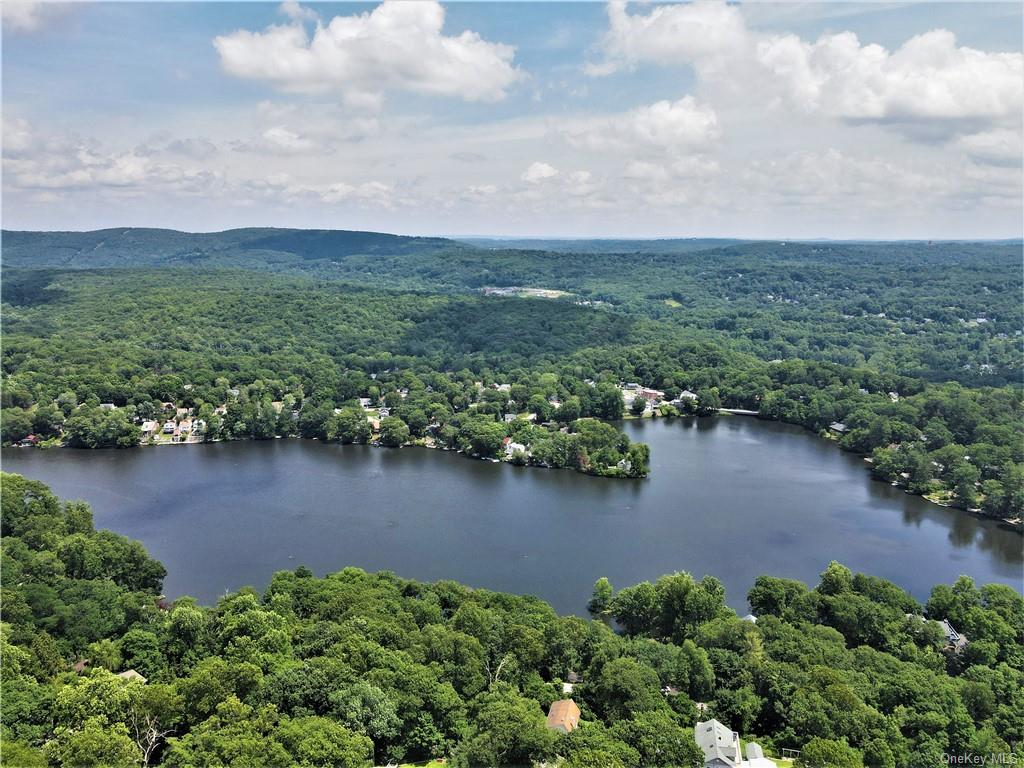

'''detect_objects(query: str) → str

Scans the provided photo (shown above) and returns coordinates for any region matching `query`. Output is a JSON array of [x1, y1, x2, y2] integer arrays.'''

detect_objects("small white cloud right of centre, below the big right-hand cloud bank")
[[565, 96, 719, 152]]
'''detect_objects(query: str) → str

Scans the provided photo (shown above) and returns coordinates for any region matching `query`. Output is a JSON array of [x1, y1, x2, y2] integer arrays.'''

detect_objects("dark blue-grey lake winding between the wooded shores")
[[3, 417, 1022, 613]]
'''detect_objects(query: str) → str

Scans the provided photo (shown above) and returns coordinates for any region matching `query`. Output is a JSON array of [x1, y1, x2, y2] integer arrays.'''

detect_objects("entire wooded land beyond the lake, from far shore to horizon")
[[2, 229, 1024, 519]]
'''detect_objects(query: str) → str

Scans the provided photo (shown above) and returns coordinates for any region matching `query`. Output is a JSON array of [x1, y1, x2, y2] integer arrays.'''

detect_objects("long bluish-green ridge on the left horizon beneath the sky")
[[3, 227, 469, 271]]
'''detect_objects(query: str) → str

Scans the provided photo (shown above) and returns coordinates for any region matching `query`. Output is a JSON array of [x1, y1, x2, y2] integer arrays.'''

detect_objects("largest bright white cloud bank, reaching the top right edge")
[[591, 2, 1024, 140]]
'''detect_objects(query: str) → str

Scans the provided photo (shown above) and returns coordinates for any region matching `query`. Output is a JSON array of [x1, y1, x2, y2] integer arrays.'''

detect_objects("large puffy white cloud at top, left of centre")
[[214, 0, 522, 106]]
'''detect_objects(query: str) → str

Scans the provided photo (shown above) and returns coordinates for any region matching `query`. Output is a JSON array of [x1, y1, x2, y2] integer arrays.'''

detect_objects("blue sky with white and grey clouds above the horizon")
[[6, 0, 1024, 239]]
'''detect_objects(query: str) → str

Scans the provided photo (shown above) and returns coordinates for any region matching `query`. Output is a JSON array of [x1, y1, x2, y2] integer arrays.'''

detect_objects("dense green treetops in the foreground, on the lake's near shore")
[[0, 474, 1024, 768]]
